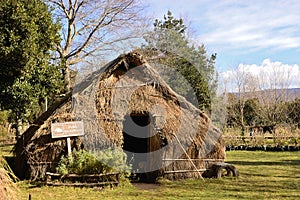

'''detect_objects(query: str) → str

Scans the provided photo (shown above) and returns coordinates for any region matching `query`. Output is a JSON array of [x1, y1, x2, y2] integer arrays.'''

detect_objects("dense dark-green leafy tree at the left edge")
[[0, 0, 63, 125]]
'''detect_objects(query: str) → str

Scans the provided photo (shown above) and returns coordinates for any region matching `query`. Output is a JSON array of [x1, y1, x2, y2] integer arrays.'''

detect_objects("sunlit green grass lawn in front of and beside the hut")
[[11, 151, 300, 200]]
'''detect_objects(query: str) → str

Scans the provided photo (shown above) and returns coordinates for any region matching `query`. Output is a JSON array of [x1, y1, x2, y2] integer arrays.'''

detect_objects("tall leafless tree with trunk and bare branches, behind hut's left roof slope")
[[46, 0, 143, 90]]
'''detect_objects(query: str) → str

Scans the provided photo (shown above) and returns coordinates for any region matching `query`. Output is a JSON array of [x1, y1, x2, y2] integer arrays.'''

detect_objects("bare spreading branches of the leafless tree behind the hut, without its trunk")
[[49, 0, 142, 60]]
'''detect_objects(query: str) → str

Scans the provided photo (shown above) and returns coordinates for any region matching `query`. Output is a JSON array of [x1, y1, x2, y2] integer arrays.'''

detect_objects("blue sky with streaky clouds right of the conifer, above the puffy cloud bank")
[[143, 0, 300, 82]]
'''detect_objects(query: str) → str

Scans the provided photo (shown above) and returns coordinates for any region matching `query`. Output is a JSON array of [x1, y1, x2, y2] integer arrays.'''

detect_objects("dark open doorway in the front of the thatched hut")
[[123, 114, 158, 182]]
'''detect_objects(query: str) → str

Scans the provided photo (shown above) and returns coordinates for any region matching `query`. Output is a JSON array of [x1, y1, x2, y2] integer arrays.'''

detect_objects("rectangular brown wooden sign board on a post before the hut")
[[51, 121, 84, 138]]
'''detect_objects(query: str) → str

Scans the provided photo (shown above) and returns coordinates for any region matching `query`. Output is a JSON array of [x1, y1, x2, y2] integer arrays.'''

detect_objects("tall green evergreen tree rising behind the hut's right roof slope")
[[143, 11, 217, 112]]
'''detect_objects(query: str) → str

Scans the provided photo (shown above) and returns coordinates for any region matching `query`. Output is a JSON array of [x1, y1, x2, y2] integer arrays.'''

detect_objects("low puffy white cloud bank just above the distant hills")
[[220, 59, 300, 92]]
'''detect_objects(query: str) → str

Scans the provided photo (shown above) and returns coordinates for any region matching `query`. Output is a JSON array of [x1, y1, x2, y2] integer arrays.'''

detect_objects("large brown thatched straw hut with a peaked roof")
[[15, 52, 225, 180]]
